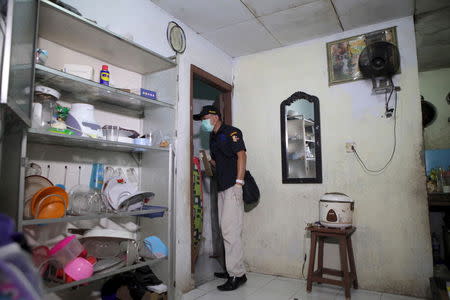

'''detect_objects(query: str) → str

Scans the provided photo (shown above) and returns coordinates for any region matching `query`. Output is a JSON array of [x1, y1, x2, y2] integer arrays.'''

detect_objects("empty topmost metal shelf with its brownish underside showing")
[[39, 0, 176, 74]]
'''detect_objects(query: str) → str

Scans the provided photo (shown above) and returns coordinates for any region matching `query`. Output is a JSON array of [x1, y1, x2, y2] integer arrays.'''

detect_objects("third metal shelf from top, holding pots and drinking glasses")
[[27, 128, 169, 152]]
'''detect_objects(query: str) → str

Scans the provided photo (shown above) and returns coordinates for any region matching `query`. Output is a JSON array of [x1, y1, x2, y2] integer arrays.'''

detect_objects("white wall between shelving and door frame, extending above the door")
[[59, 0, 232, 292]]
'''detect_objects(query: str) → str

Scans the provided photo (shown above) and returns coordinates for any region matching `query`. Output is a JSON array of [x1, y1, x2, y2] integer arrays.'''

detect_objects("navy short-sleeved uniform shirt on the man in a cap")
[[209, 123, 246, 192]]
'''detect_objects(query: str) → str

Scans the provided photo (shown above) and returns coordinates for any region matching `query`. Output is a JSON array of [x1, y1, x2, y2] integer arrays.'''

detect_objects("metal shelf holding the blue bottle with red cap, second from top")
[[35, 65, 174, 115]]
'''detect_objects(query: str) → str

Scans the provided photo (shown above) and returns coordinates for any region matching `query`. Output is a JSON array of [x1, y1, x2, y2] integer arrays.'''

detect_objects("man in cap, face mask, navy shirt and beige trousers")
[[194, 105, 247, 291]]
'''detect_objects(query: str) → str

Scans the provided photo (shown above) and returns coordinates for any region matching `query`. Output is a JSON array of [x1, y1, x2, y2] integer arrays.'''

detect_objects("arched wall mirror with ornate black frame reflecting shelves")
[[280, 92, 322, 183]]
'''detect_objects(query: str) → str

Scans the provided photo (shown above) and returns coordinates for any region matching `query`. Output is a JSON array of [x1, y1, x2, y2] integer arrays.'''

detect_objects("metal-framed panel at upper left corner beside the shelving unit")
[[0, 0, 39, 126]]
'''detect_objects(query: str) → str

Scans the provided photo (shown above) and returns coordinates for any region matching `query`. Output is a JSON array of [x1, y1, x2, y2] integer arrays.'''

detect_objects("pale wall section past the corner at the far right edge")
[[419, 68, 450, 150]]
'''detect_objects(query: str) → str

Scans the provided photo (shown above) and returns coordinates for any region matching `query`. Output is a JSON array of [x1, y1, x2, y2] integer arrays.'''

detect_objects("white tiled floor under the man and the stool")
[[183, 273, 426, 300]]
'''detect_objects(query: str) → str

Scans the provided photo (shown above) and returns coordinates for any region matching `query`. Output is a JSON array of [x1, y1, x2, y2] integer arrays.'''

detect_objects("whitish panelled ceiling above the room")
[[151, 0, 450, 69]]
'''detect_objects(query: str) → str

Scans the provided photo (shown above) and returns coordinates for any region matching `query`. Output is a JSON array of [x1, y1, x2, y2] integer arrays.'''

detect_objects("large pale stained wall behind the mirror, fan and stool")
[[233, 17, 432, 296]]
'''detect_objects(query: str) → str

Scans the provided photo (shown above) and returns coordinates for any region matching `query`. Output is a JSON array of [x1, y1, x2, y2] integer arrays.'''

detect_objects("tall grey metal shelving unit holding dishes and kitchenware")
[[13, 0, 177, 299]]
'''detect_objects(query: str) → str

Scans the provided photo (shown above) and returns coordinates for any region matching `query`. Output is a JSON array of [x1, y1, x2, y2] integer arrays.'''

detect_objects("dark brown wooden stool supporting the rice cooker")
[[306, 226, 358, 299]]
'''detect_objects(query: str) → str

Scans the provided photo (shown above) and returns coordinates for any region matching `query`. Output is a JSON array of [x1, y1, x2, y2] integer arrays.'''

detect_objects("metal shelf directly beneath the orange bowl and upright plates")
[[22, 208, 168, 226]]
